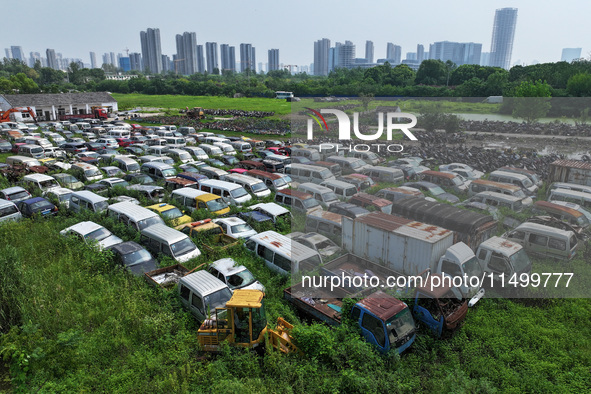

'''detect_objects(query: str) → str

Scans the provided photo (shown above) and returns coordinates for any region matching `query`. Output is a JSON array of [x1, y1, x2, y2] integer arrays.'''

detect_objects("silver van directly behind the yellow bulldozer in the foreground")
[[178, 270, 232, 323]]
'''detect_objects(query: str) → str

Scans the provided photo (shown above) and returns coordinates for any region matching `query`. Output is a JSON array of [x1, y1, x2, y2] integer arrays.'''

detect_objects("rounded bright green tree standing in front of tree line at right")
[[510, 80, 551, 123]]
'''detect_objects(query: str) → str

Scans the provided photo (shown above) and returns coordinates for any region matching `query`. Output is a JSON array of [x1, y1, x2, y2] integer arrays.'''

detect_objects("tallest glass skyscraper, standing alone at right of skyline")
[[490, 8, 517, 69]]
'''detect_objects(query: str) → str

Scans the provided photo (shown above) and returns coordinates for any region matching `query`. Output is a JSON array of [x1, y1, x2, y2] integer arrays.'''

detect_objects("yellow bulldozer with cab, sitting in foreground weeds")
[[198, 289, 298, 353]]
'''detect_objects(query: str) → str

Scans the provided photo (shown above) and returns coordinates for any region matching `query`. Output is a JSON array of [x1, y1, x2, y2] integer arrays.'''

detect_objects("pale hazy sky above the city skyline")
[[0, 0, 591, 65]]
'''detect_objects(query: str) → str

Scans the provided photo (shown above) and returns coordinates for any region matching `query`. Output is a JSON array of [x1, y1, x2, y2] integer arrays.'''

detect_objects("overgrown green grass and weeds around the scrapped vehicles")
[[0, 114, 591, 392]]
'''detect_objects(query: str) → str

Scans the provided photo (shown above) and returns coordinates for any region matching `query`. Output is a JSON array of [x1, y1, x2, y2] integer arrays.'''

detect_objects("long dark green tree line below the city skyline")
[[0, 58, 591, 97]]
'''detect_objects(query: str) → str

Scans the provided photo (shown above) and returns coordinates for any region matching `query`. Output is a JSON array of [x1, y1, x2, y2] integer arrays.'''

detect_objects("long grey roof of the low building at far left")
[[3, 92, 117, 107]]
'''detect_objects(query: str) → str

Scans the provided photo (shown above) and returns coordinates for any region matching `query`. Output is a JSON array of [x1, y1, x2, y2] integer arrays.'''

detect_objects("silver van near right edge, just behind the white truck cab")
[[503, 222, 578, 260]]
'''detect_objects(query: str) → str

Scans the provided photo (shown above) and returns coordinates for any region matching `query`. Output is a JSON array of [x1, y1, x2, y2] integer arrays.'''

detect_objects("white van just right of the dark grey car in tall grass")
[[140, 224, 201, 263]]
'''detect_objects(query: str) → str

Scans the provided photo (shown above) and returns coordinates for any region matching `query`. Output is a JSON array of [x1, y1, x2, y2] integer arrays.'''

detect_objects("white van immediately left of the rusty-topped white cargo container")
[[244, 231, 322, 275]]
